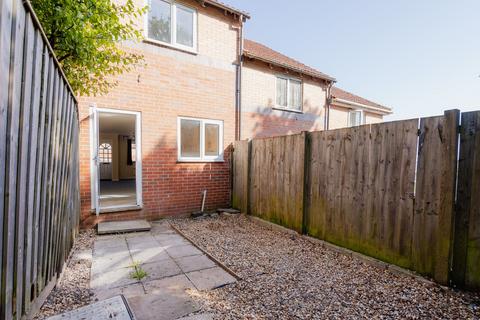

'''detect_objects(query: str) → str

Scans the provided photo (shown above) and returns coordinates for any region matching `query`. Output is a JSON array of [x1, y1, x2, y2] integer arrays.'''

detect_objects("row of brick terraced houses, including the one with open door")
[[79, 0, 390, 226]]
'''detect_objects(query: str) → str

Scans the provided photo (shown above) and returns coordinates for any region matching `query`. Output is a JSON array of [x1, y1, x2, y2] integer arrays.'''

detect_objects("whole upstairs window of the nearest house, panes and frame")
[[146, 0, 197, 50]]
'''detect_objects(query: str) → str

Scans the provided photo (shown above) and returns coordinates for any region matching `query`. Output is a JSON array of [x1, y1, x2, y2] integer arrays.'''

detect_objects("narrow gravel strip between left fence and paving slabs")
[[34, 230, 95, 319]]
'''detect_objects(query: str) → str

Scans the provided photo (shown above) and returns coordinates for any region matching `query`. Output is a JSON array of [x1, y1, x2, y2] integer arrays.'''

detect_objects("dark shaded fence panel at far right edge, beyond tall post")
[[452, 111, 480, 289]]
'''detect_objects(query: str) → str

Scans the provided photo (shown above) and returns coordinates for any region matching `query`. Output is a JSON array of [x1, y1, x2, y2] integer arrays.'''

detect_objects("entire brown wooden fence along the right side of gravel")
[[232, 110, 480, 288]]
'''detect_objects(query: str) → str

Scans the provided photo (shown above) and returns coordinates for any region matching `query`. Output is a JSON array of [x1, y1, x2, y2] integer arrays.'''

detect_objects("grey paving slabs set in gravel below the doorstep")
[[90, 222, 236, 320]]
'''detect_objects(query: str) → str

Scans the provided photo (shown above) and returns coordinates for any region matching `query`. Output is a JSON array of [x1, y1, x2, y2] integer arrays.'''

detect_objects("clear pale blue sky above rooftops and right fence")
[[223, 0, 480, 120]]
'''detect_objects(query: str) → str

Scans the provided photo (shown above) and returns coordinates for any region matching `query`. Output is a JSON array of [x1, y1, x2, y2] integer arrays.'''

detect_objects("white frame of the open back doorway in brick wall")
[[89, 104, 143, 215]]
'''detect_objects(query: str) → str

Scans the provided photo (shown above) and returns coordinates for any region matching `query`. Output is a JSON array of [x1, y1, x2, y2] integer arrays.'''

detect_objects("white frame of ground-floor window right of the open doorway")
[[177, 117, 223, 162]]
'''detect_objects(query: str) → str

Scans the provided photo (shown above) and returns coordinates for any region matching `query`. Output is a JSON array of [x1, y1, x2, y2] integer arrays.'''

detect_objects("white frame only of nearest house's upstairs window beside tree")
[[144, 0, 198, 53]]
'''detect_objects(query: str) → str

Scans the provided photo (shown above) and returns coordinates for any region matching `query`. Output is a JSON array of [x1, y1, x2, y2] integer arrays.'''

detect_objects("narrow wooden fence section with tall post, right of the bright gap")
[[412, 111, 459, 284]]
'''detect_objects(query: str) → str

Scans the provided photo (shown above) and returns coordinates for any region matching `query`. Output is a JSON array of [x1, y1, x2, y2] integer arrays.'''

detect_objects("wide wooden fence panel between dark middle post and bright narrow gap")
[[306, 120, 418, 266]]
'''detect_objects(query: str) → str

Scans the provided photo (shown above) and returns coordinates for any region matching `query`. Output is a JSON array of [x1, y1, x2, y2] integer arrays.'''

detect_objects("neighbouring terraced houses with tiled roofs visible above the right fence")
[[240, 39, 392, 139]]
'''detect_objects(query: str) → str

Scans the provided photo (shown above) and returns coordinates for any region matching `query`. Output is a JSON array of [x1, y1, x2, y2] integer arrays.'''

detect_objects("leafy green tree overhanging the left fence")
[[31, 0, 146, 95]]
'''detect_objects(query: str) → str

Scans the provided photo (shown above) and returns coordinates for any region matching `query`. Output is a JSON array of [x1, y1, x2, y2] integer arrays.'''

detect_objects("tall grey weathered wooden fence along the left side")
[[0, 0, 80, 319]]
